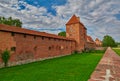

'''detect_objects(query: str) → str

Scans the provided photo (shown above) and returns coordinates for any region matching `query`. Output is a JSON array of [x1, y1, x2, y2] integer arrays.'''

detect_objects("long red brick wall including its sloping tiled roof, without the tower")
[[0, 25, 75, 66]]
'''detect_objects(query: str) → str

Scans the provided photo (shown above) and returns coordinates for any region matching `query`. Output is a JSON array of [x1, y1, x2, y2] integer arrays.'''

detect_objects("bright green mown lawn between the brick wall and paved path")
[[0, 52, 104, 81]]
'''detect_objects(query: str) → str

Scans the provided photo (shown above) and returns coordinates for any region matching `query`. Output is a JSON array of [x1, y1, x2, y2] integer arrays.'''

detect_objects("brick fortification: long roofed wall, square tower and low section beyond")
[[0, 15, 95, 66]]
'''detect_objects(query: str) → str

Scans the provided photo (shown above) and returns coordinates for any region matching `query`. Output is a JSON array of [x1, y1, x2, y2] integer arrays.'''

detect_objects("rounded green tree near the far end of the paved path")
[[102, 35, 116, 47]]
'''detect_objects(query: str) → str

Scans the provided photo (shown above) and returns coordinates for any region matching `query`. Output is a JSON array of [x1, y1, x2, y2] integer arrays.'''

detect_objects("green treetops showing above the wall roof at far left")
[[0, 17, 22, 27]]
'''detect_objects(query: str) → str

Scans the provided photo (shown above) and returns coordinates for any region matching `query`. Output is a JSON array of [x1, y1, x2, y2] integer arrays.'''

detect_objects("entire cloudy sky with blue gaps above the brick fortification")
[[0, 0, 120, 41]]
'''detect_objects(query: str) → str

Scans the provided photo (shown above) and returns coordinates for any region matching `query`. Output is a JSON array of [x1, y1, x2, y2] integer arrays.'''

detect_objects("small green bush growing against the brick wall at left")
[[1, 50, 10, 67]]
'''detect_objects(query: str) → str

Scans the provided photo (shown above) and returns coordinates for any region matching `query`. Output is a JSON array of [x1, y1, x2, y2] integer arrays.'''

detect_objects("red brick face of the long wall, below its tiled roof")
[[0, 31, 75, 66]]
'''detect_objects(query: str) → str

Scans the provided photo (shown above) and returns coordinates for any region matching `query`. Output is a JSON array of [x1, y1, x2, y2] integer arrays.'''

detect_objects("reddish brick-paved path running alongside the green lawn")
[[88, 47, 120, 81]]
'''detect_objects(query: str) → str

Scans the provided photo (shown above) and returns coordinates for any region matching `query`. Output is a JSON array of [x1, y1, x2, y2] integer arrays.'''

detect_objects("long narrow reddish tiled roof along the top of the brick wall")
[[0, 24, 74, 40]]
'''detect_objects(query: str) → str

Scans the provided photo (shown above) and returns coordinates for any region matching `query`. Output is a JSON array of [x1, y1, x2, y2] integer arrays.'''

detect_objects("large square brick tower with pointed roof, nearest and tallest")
[[66, 15, 87, 51]]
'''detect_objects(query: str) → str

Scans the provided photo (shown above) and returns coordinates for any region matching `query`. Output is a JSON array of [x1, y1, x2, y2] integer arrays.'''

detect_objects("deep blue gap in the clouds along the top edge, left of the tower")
[[19, 0, 67, 15]]
